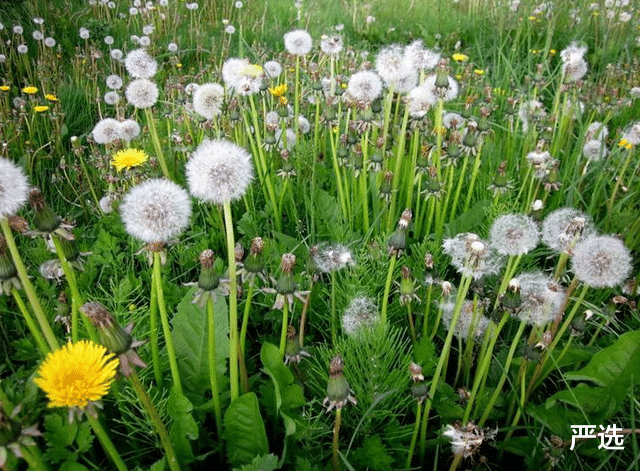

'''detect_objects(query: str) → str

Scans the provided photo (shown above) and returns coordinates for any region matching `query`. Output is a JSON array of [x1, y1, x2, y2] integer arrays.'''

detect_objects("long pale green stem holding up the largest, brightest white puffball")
[[222, 201, 240, 402]]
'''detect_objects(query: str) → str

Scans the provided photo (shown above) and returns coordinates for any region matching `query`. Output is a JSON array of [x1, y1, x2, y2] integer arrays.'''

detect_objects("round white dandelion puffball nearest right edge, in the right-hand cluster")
[[571, 236, 631, 288]]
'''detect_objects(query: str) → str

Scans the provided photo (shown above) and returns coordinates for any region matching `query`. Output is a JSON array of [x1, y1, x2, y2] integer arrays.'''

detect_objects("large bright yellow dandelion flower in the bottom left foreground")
[[34, 340, 119, 409]]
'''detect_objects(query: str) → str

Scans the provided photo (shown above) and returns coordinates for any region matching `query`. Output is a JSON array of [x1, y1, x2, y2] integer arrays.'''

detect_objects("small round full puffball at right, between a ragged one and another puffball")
[[491, 214, 540, 255]]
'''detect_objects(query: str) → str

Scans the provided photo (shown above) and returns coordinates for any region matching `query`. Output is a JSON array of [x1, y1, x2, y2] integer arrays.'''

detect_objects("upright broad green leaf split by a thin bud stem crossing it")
[[173, 286, 229, 404]]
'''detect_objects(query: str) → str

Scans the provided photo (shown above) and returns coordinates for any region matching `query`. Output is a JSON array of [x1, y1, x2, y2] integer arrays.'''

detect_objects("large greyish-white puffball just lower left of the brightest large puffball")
[[120, 178, 191, 243]]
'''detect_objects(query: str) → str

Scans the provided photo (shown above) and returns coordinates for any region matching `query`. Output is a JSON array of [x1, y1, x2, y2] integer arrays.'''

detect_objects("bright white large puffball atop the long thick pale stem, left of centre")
[[186, 139, 253, 204]]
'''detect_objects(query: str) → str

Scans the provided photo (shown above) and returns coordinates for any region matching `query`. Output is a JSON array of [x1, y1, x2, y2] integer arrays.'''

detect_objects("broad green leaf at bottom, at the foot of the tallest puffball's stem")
[[224, 393, 269, 467]]
